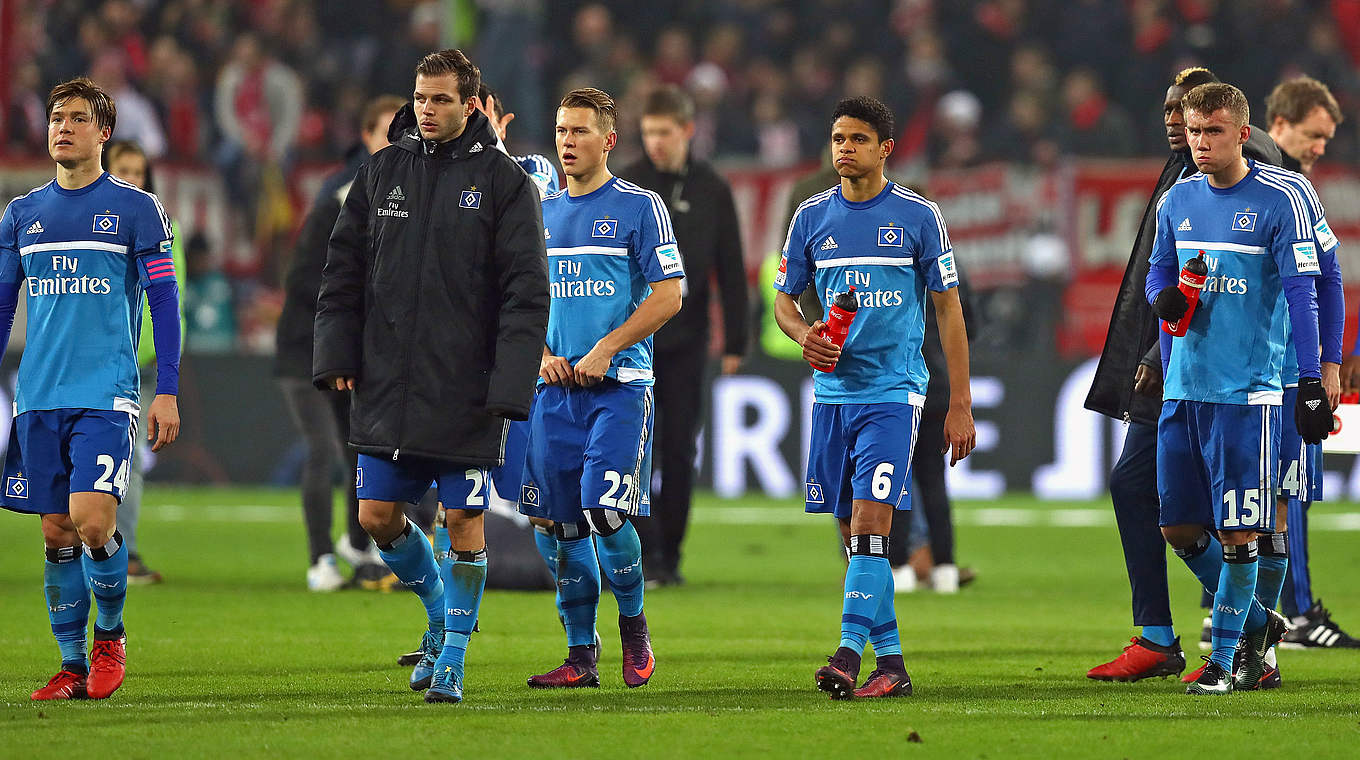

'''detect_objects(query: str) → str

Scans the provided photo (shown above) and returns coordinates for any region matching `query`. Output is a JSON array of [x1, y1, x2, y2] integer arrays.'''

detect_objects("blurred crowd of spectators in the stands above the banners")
[[0, 0, 1360, 353]]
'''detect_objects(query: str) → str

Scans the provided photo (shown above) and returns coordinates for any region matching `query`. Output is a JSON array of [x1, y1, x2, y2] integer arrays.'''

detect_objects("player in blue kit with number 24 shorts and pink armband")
[[0, 77, 180, 699]]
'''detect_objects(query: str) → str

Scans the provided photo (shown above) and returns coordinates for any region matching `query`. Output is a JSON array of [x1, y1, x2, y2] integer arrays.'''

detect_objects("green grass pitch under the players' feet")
[[0, 487, 1360, 760]]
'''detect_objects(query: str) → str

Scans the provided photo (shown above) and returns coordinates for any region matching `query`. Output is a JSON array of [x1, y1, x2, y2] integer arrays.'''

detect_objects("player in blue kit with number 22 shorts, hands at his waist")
[[520, 87, 684, 688]]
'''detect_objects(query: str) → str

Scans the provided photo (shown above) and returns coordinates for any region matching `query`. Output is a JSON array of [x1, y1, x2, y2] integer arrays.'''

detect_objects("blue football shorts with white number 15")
[[1157, 400, 1280, 533]]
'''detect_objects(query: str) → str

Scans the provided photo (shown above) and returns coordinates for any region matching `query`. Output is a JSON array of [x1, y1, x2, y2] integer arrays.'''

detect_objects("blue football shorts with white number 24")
[[3, 409, 137, 514]]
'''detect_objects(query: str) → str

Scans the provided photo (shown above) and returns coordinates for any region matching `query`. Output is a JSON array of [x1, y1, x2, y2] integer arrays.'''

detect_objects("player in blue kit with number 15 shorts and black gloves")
[[1146, 83, 1331, 695]]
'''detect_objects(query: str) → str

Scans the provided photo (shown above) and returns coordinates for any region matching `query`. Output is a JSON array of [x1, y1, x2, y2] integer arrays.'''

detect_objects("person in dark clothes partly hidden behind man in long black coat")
[[273, 95, 405, 591]]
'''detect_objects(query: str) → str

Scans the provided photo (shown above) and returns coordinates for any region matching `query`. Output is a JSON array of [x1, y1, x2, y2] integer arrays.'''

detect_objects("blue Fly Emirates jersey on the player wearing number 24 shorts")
[[0, 174, 173, 413]]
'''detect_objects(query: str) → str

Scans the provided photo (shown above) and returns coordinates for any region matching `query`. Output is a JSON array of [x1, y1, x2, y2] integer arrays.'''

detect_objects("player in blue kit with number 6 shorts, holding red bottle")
[[774, 98, 975, 699]]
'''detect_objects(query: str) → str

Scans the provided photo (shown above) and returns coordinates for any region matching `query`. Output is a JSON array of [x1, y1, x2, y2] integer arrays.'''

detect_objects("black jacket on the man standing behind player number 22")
[[619, 156, 751, 356]]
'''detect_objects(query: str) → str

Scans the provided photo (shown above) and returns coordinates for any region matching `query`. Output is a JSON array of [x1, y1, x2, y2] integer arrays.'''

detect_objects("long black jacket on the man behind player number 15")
[[1085, 126, 1280, 424]]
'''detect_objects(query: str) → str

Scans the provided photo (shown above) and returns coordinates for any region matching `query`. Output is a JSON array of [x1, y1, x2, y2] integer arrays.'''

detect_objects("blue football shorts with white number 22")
[[520, 378, 653, 522]]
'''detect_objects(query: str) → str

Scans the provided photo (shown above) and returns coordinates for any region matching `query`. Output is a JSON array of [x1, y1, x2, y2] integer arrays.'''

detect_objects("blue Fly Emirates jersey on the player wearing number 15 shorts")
[[1152, 160, 1322, 404]]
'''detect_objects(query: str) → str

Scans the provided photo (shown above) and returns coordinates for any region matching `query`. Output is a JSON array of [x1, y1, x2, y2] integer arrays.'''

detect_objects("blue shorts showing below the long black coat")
[[354, 454, 488, 510]]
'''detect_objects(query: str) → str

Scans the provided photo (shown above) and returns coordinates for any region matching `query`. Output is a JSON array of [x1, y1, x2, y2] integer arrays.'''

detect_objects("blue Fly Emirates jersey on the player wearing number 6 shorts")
[[774, 182, 959, 407]]
